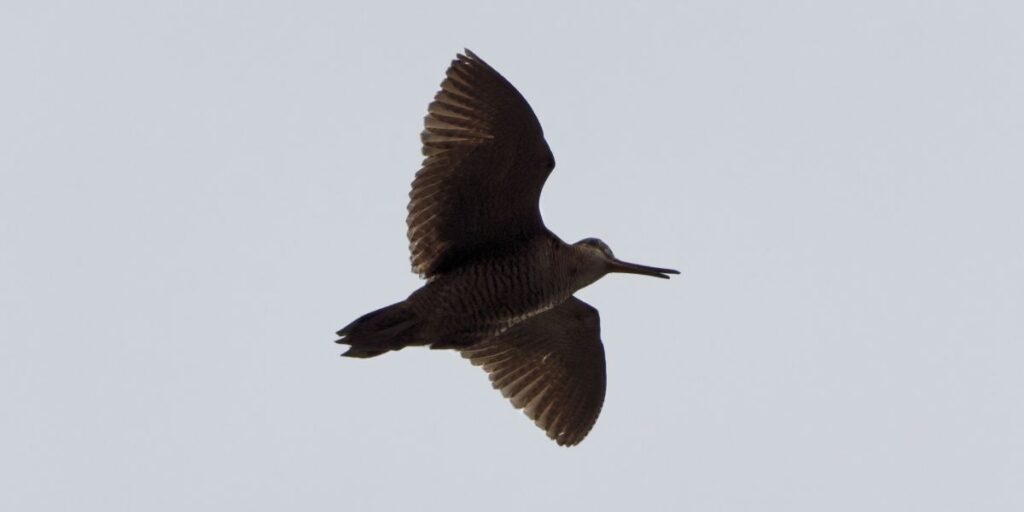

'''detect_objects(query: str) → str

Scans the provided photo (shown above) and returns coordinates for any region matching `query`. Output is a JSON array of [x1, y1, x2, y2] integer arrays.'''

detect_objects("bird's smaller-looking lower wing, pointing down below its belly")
[[461, 297, 606, 445]]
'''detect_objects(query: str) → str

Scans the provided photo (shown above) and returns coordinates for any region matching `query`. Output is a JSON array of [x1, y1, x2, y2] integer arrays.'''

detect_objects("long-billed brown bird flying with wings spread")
[[338, 50, 679, 445]]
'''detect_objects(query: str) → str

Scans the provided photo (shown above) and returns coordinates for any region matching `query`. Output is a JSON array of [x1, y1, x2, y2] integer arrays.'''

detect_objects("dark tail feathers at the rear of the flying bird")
[[337, 301, 420, 357]]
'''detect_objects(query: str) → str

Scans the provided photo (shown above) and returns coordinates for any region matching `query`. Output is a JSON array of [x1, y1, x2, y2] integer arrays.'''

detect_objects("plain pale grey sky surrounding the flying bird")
[[0, 0, 1024, 511]]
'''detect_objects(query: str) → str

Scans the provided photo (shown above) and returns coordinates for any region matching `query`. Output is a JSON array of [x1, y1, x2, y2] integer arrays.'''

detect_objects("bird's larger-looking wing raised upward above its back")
[[407, 50, 555, 278]]
